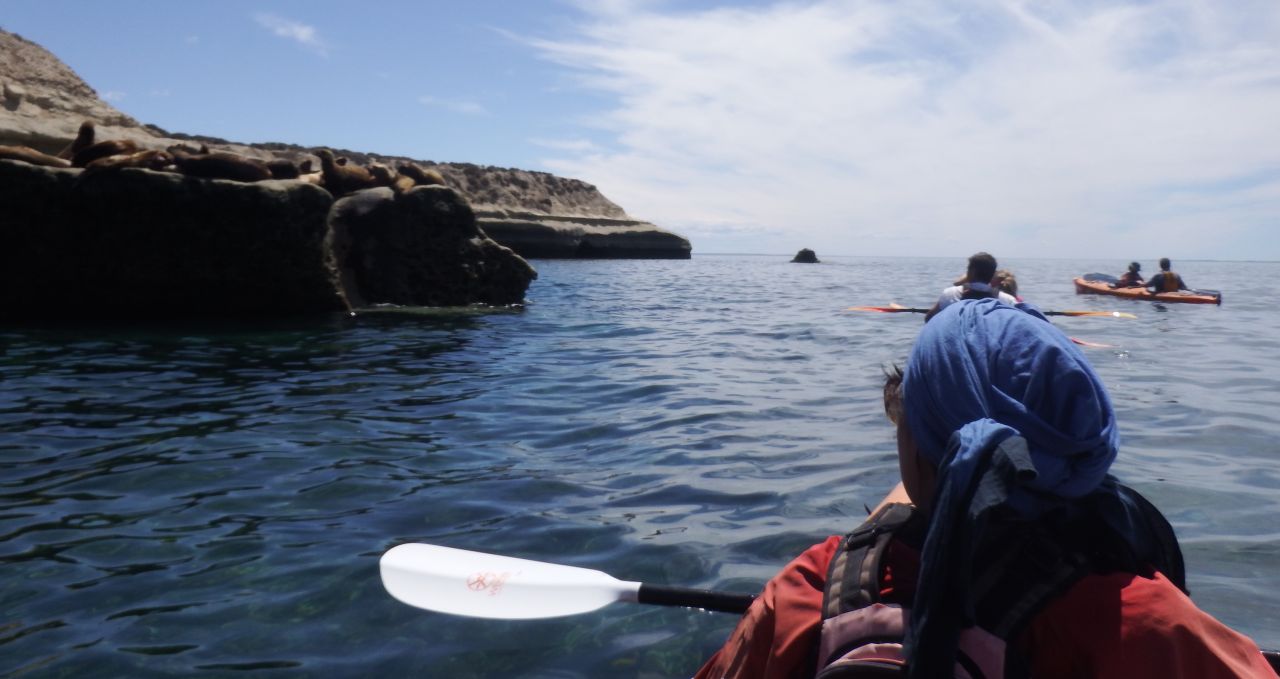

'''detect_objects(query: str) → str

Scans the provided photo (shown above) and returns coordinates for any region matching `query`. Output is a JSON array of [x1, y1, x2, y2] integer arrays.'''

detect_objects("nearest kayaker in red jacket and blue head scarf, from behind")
[[696, 300, 1275, 679]]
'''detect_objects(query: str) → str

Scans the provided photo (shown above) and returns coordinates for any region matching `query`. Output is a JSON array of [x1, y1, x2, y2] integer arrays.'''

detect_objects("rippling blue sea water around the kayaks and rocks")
[[0, 252, 1280, 678]]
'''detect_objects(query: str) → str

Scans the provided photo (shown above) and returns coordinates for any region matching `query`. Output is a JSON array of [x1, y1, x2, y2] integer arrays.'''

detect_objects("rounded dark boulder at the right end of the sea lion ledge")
[[329, 186, 538, 307]]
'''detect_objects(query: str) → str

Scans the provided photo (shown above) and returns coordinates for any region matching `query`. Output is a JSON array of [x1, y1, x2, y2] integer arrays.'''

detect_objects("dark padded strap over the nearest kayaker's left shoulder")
[[822, 502, 916, 619]]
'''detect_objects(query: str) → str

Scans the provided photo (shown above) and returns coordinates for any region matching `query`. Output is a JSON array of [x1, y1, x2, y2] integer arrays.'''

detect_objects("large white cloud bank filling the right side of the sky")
[[530, 0, 1280, 259]]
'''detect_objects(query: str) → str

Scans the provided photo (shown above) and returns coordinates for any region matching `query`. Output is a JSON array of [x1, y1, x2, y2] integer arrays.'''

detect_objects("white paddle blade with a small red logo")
[[379, 543, 640, 620]]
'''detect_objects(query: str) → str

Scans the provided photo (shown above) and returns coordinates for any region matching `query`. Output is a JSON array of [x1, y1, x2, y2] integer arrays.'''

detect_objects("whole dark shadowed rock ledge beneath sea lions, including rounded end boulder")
[[0, 155, 536, 320]]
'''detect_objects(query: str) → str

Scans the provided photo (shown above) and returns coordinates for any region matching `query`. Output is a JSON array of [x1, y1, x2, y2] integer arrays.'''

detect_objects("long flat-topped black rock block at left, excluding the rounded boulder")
[[0, 160, 347, 320]]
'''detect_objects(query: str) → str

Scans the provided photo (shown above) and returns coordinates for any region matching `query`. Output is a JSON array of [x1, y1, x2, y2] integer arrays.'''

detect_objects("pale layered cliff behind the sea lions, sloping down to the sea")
[[0, 29, 690, 259]]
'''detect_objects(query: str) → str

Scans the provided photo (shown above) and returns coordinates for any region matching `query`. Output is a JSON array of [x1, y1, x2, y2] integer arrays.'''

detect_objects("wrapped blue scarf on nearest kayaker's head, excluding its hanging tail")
[[902, 300, 1120, 498]]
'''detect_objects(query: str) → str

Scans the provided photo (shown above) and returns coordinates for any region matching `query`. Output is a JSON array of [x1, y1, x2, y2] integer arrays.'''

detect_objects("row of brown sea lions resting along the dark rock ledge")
[[0, 120, 444, 197]]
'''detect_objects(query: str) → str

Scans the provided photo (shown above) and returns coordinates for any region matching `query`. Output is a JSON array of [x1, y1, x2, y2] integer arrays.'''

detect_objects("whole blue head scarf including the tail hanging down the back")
[[902, 300, 1119, 676]]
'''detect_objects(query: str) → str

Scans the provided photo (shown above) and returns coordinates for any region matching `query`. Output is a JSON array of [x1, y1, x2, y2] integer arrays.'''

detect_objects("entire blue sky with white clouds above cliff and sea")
[[0, 0, 1280, 256]]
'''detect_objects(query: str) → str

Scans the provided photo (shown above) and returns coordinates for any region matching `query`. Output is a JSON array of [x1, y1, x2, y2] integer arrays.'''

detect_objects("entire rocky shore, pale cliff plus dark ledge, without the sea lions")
[[0, 29, 690, 320]]
